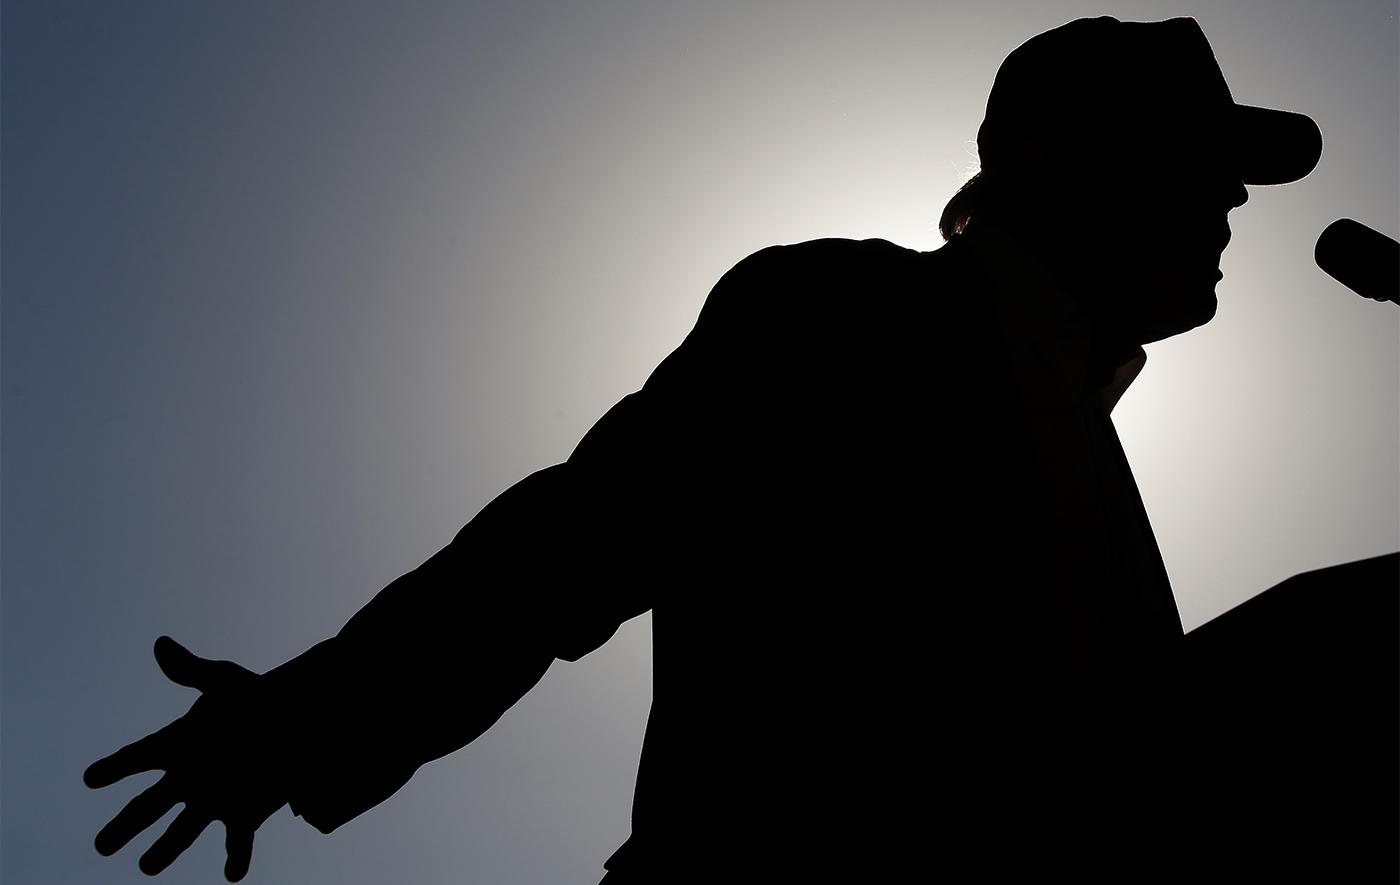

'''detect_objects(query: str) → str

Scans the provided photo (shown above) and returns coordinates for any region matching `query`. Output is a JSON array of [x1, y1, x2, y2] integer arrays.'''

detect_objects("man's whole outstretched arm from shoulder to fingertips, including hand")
[[84, 242, 802, 881]]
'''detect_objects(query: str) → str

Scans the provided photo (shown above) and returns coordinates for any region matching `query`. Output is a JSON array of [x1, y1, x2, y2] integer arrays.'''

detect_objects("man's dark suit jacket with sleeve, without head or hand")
[[278, 231, 1180, 884]]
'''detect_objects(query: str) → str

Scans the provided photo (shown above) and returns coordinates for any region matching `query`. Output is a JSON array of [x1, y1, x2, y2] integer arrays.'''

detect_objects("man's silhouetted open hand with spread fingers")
[[83, 636, 286, 882]]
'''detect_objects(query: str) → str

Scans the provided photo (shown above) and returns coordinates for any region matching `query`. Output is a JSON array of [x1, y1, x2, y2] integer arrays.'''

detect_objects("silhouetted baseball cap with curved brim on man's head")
[[977, 15, 1322, 185]]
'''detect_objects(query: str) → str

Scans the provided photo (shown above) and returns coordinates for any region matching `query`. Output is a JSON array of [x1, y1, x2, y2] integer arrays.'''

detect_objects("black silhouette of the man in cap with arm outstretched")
[[87, 18, 1393, 885]]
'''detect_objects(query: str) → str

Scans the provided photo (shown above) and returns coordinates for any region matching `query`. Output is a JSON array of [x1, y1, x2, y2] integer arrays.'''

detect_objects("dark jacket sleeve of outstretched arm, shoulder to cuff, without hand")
[[266, 247, 795, 833]]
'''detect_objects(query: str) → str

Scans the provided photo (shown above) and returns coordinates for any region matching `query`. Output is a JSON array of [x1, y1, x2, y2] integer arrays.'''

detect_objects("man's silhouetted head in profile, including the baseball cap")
[[941, 17, 1322, 343]]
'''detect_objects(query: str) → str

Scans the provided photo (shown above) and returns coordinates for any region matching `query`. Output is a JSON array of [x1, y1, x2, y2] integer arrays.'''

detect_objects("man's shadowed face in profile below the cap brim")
[[1091, 143, 1249, 344]]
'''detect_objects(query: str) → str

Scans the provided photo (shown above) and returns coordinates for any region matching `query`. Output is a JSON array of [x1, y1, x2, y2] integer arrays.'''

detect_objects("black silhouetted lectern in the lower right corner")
[[1180, 553, 1400, 882]]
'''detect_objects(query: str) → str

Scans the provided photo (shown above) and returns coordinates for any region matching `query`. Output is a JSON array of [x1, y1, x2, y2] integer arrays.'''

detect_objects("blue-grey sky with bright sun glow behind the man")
[[0, 0, 1400, 885]]
